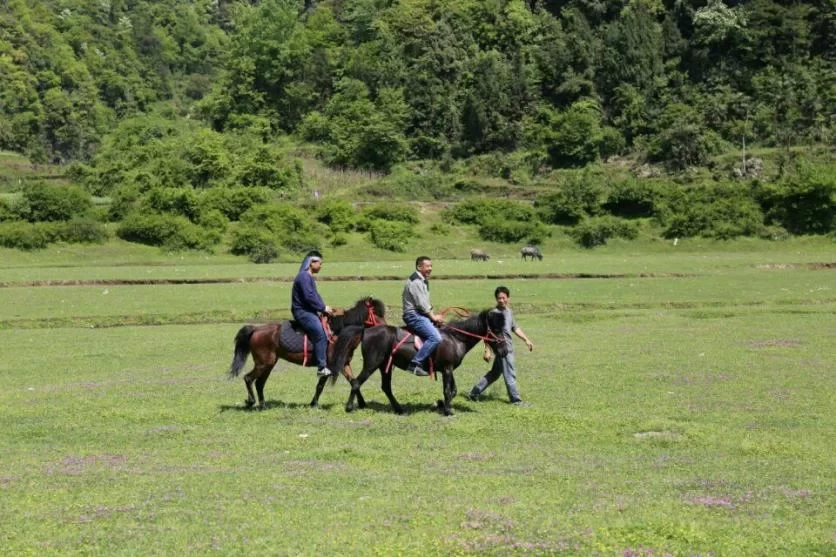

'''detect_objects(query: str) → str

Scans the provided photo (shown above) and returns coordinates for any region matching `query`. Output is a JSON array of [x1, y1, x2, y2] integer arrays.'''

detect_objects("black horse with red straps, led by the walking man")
[[334, 310, 508, 416]]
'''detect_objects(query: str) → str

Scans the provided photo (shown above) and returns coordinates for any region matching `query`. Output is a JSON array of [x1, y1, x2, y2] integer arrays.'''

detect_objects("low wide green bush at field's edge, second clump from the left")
[[116, 213, 220, 250]]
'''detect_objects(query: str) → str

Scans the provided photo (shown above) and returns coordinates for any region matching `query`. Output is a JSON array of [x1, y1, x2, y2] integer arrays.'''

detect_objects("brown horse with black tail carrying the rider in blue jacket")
[[229, 296, 386, 409]]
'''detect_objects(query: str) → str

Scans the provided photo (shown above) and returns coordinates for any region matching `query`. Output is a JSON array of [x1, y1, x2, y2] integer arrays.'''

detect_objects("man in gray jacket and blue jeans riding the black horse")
[[403, 255, 444, 376]]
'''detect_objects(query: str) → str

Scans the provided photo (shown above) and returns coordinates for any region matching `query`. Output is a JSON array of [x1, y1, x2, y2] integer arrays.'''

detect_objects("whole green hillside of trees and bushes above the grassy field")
[[0, 0, 836, 256]]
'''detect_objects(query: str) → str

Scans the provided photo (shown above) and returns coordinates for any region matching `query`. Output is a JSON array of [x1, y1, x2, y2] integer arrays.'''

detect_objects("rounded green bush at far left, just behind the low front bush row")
[[18, 182, 93, 222]]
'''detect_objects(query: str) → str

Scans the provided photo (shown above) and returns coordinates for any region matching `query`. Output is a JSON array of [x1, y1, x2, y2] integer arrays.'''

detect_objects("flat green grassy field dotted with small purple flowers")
[[0, 240, 836, 557]]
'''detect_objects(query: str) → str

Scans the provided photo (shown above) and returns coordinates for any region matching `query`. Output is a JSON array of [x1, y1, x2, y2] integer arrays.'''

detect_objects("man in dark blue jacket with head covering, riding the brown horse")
[[290, 250, 332, 377]]
